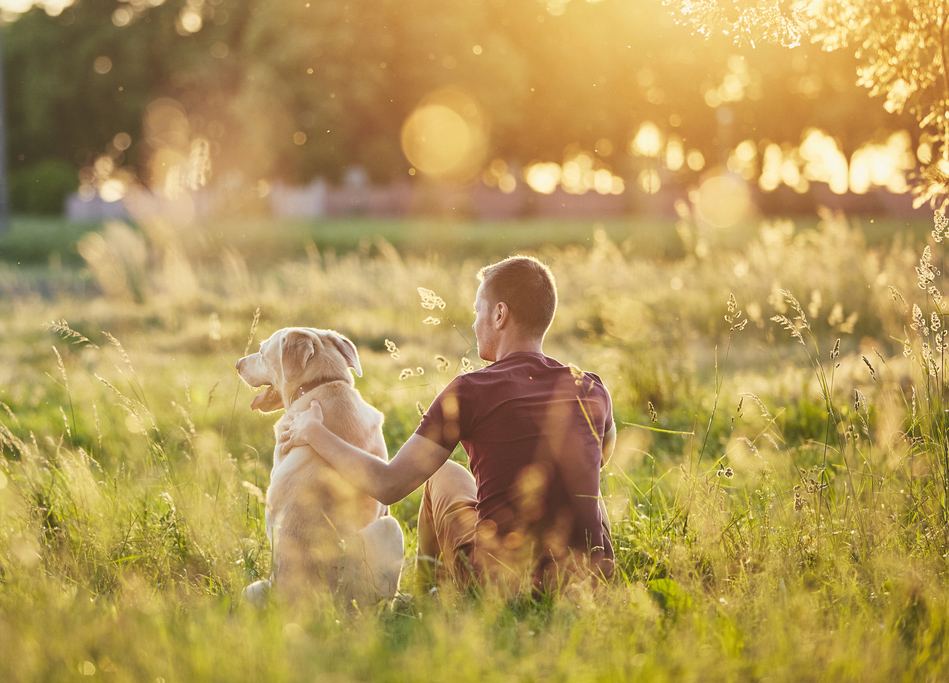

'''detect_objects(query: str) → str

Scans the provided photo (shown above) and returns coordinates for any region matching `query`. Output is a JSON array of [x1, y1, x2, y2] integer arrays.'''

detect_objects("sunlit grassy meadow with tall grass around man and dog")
[[0, 213, 949, 682]]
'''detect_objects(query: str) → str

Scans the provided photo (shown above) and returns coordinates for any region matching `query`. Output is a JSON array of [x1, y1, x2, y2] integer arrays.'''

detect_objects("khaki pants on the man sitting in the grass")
[[415, 460, 612, 591]]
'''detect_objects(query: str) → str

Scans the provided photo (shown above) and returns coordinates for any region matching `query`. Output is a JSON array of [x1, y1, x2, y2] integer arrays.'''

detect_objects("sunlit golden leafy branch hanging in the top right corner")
[[663, 0, 949, 208]]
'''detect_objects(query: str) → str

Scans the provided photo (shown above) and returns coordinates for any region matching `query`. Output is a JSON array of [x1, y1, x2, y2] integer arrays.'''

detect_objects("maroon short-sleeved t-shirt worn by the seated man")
[[416, 352, 613, 584]]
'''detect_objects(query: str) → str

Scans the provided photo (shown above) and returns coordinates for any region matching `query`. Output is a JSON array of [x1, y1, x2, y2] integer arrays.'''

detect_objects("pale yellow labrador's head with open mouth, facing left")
[[237, 327, 362, 413]]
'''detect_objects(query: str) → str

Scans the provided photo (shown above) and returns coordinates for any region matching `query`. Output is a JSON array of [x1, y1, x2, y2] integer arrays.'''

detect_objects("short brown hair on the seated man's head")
[[478, 256, 557, 337]]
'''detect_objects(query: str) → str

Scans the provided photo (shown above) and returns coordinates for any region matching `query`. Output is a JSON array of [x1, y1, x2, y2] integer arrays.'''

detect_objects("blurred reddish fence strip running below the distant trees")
[[65, 180, 913, 221]]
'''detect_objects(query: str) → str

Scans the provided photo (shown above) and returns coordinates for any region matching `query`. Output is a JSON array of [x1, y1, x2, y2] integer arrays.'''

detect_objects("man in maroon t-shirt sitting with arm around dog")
[[281, 256, 616, 592]]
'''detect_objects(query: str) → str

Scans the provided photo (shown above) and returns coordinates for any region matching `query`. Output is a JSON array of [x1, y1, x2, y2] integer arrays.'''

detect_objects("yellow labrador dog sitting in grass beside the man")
[[237, 327, 403, 607]]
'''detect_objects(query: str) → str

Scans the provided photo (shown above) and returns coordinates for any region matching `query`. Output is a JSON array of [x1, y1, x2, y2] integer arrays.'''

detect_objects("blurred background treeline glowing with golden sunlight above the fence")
[[2, 0, 940, 223]]
